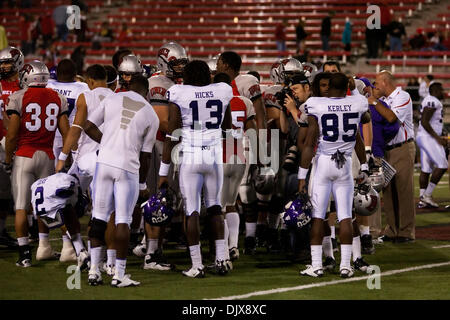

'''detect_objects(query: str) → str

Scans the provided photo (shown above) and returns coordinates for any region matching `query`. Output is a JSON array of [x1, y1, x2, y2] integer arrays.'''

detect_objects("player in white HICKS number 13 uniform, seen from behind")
[[160, 60, 233, 278]]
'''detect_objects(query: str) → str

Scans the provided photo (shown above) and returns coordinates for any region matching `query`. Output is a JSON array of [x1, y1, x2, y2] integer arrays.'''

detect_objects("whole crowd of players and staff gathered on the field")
[[0, 42, 447, 287]]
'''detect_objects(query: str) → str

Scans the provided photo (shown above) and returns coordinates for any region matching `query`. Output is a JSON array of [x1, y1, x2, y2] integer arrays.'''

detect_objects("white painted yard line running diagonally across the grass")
[[209, 261, 450, 300]]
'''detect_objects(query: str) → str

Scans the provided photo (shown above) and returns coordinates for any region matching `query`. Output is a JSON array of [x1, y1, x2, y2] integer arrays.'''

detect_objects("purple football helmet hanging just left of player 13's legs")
[[141, 189, 175, 226]]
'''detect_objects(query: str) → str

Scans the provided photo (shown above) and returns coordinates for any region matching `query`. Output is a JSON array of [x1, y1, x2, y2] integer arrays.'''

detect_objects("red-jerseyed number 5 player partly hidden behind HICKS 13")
[[214, 73, 256, 265]]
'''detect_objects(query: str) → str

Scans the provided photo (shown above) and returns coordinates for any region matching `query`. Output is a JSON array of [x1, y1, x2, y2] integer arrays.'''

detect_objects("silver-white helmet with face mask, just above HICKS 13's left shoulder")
[[156, 41, 189, 80]]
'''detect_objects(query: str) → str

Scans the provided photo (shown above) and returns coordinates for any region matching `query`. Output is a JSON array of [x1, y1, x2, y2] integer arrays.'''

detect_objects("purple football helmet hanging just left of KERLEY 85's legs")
[[283, 194, 312, 229]]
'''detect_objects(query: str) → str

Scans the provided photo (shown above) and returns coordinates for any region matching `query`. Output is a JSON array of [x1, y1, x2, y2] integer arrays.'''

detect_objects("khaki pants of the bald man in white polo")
[[384, 141, 416, 239]]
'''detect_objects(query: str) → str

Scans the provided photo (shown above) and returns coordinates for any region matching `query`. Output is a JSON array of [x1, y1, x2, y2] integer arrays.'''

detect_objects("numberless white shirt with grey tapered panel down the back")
[[88, 91, 159, 174]]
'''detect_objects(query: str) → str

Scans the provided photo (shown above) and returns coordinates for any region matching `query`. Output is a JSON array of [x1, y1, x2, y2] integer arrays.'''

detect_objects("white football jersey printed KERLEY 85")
[[305, 95, 369, 156]]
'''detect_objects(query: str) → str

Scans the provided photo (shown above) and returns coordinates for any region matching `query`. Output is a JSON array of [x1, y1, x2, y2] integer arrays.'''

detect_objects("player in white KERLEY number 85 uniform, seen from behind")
[[299, 73, 368, 278]]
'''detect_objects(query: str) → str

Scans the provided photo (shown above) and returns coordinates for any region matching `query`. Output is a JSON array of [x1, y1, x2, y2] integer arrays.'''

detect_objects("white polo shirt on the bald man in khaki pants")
[[381, 87, 414, 145]]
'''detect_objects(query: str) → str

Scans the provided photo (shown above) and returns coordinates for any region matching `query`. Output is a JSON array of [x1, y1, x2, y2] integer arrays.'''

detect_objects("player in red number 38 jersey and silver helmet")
[[4, 61, 69, 267]]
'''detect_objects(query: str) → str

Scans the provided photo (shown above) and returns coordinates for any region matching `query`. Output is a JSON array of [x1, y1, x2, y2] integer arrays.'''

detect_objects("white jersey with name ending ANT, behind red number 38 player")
[[47, 81, 90, 141]]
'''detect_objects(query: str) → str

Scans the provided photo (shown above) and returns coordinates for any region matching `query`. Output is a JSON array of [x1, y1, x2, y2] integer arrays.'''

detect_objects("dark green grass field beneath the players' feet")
[[0, 175, 450, 300]]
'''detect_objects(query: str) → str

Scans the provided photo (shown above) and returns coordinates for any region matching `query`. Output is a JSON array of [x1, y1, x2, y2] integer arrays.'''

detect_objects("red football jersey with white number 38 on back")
[[6, 87, 68, 160]]
